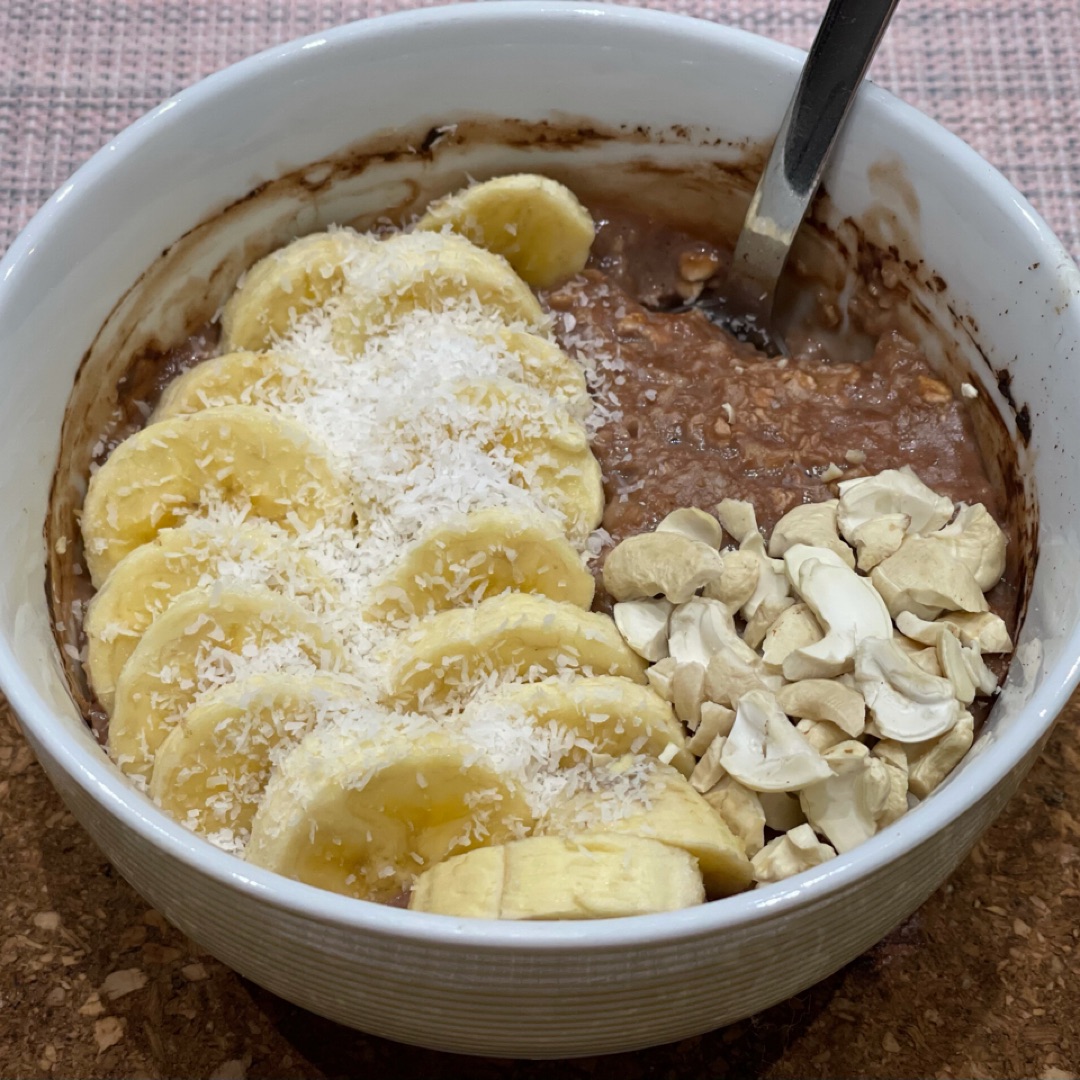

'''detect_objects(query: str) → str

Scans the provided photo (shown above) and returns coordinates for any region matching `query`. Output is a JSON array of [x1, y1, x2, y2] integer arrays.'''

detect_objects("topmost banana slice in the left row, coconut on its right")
[[221, 229, 376, 352]]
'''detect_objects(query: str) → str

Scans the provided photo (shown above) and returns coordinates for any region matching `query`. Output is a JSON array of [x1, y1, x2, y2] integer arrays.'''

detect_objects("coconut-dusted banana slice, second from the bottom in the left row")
[[150, 674, 364, 843]]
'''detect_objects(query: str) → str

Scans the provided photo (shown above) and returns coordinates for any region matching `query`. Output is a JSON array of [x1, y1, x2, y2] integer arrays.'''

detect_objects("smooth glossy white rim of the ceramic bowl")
[[6, 0, 1080, 953]]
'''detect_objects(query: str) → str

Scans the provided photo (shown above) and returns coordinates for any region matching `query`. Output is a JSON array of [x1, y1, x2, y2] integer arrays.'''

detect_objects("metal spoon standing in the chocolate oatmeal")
[[688, 0, 897, 355]]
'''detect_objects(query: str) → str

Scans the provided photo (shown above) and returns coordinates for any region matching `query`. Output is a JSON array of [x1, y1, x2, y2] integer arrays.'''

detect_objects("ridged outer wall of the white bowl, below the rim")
[[23, 717, 1037, 1057]]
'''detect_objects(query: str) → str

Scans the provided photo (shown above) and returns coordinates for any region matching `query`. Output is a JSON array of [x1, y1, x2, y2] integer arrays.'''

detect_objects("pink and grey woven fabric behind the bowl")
[[0, 0, 1080, 256]]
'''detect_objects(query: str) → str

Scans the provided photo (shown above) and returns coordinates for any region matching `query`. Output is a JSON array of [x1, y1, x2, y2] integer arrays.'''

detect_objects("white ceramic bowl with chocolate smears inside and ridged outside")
[[0, 2, 1080, 1056]]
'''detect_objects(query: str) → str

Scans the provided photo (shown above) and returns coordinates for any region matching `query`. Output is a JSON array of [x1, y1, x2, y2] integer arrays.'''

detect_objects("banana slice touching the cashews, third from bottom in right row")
[[464, 675, 697, 777]]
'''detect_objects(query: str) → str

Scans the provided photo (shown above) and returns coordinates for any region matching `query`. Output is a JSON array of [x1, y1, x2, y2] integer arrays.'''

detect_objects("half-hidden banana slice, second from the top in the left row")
[[150, 352, 306, 423]]
